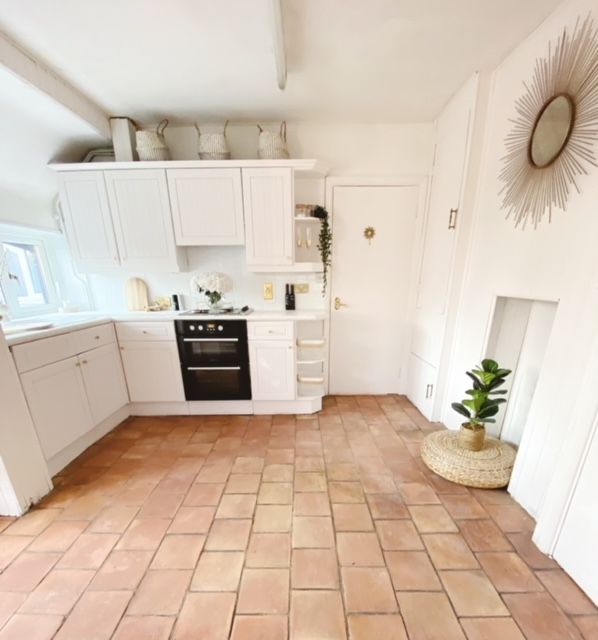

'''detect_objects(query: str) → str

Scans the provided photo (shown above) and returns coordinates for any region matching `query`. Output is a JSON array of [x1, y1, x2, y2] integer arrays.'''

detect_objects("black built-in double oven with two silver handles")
[[175, 319, 251, 400]]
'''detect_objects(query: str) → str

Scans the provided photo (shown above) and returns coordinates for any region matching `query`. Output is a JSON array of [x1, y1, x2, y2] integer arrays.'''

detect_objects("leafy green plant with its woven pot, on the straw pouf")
[[451, 358, 511, 451]]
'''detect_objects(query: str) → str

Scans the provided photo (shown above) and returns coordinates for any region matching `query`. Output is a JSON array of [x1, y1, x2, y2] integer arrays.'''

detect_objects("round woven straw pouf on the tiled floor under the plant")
[[421, 429, 516, 489]]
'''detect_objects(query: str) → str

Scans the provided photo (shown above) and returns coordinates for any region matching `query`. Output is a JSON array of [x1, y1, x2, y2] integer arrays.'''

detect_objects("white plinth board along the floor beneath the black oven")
[[129, 398, 322, 416]]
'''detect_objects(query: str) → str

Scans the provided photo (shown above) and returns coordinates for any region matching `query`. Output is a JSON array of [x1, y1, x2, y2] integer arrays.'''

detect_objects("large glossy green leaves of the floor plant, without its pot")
[[451, 358, 511, 430]]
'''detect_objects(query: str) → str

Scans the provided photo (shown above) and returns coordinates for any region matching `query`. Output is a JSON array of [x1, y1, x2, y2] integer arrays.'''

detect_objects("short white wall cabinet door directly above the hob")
[[166, 169, 245, 246]]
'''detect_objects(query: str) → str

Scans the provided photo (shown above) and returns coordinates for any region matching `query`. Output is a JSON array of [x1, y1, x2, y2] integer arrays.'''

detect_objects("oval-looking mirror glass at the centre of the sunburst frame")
[[529, 95, 575, 168]]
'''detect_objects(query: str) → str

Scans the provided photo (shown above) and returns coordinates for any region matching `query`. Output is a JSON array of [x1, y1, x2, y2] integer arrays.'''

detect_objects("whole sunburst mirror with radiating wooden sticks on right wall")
[[500, 15, 598, 228]]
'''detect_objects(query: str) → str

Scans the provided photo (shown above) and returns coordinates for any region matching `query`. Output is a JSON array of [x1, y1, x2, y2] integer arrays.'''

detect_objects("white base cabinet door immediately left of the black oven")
[[121, 341, 185, 402]]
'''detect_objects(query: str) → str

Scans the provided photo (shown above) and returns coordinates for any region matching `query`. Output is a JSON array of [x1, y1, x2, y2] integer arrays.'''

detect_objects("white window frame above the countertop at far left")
[[0, 227, 59, 318]]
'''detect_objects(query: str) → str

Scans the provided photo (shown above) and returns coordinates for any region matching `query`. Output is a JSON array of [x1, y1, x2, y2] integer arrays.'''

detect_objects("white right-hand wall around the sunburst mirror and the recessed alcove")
[[442, 0, 598, 548]]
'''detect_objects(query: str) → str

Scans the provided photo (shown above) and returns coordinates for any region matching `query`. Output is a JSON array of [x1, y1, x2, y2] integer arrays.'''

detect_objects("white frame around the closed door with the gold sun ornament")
[[325, 174, 430, 393]]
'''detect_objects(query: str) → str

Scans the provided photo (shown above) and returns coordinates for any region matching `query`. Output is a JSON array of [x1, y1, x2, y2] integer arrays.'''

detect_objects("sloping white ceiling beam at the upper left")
[[0, 31, 111, 139]]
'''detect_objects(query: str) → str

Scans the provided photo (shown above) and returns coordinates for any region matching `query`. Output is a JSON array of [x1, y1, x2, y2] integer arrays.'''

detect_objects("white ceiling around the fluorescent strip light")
[[0, 0, 559, 122]]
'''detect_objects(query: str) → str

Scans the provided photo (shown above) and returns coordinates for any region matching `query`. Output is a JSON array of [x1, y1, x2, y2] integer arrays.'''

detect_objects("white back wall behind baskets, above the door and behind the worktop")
[[90, 123, 434, 310]]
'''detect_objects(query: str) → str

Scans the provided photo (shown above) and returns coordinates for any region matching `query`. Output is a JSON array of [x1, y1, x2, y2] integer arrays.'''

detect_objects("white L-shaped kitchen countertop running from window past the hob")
[[6, 310, 328, 346]]
